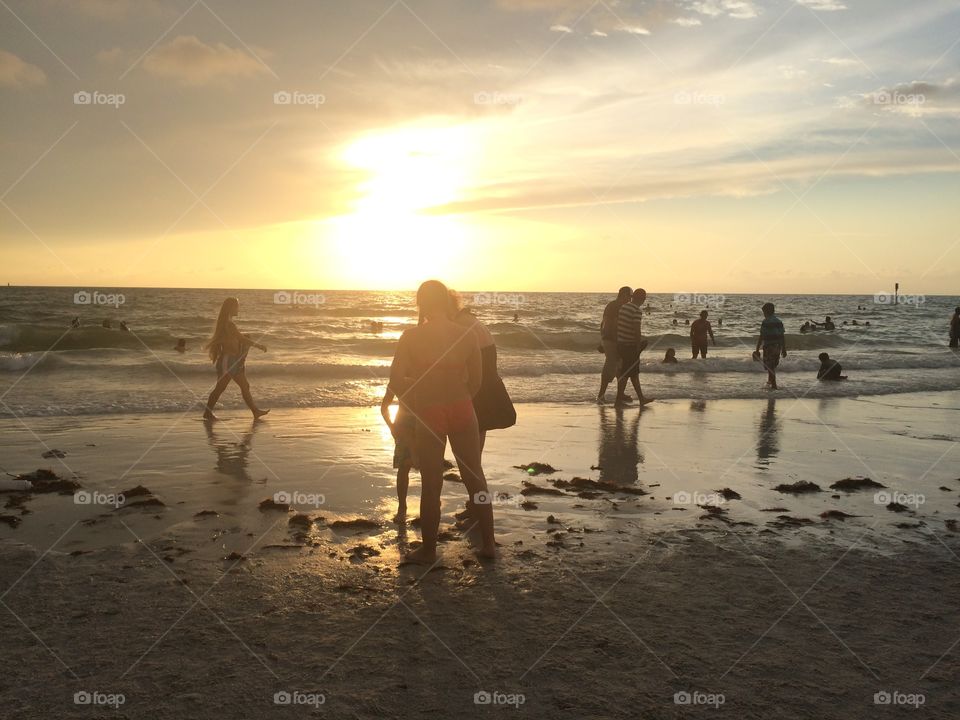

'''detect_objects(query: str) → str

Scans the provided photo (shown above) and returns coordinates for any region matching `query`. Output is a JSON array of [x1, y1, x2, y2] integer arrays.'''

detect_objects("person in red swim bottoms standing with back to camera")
[[390, 280, 496, 564]]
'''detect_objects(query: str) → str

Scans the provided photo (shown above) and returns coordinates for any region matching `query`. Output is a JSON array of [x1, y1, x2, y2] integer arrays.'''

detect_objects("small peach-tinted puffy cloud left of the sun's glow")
[[143, 35, 266, 85]]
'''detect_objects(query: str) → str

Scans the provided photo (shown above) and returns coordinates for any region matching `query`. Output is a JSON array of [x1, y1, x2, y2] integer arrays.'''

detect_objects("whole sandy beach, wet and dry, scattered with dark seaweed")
[[0, 393, 960, 718]]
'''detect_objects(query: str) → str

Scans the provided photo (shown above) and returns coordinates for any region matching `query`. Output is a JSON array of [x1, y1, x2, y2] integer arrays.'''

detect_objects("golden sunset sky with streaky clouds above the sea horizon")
[[0, 0, 960, 295]]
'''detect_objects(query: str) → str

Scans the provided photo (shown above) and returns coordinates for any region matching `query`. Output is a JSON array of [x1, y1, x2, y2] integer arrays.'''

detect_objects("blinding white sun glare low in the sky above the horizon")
[[328, 127, 475, 288]]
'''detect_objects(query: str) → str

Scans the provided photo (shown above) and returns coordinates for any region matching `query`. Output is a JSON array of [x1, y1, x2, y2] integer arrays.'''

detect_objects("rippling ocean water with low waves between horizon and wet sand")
[[0, 287, 960, 416]]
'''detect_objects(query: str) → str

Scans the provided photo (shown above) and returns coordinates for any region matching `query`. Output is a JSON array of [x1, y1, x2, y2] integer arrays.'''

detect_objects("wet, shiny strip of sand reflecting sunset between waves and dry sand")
[[0, 392, 960, 547]]
